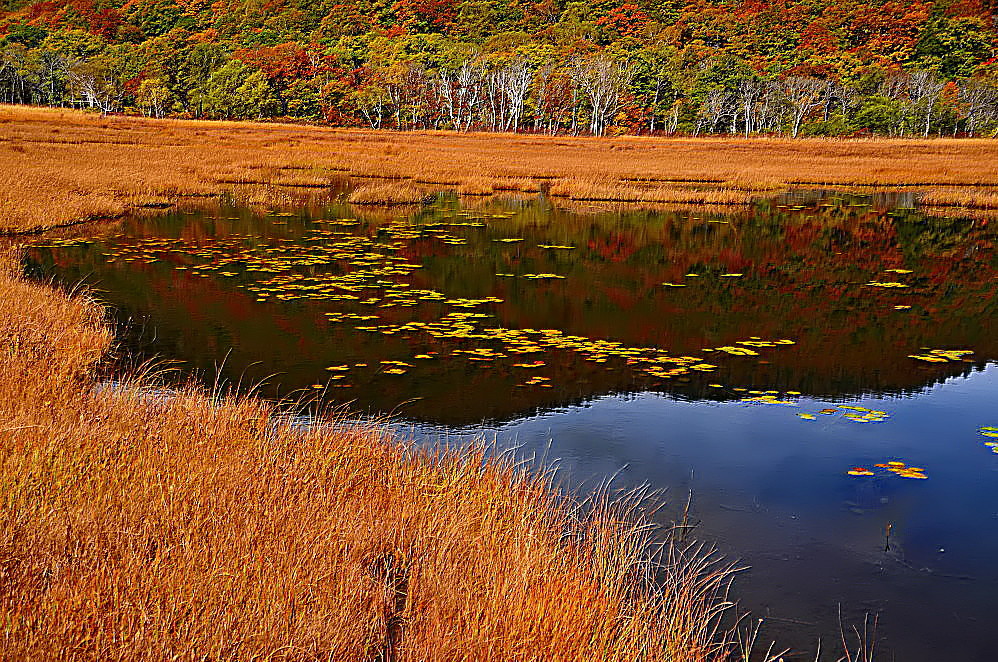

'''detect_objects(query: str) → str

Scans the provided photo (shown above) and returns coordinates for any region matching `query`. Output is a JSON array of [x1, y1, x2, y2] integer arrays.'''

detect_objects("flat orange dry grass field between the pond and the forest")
[[0, 106, 998, 232]]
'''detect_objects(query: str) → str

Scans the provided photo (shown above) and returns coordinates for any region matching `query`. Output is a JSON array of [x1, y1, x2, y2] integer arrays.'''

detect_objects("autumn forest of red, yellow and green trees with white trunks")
[[0, 0, 998, 136]]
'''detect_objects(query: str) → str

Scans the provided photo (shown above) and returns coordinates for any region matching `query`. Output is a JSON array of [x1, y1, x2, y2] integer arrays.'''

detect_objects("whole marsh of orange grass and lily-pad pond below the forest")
[[0, 109, 998, 662]]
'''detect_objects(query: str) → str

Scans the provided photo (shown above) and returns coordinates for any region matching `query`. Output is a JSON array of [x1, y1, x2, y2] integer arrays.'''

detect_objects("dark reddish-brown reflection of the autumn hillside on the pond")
[[25, 193, 998, 424]]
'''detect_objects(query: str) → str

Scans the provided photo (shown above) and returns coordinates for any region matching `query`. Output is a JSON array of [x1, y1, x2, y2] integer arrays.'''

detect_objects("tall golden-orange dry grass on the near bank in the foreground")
[[0, 252, 740, 662]]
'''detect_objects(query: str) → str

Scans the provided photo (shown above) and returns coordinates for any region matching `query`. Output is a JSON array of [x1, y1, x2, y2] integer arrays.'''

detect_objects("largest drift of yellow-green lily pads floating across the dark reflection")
[[37, 212, 812, 394]]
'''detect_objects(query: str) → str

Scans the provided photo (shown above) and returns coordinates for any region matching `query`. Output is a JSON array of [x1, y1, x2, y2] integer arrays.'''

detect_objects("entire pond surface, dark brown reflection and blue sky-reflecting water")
[[28, 192, 998, 662]]
